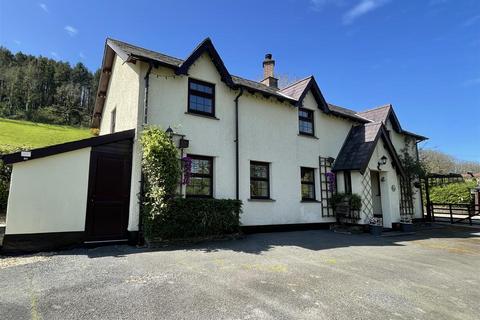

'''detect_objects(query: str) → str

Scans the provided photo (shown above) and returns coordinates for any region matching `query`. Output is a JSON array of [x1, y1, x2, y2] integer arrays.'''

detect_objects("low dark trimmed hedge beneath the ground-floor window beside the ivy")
[[144, 198, 242, 240]]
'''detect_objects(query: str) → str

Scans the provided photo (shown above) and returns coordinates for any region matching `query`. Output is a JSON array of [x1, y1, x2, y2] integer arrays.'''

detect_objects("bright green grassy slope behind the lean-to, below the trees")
[[0, 118, 92, 152]]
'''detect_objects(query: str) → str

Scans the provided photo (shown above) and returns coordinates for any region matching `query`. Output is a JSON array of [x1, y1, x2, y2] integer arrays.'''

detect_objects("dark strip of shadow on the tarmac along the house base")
[[13, 225, 474, 258]]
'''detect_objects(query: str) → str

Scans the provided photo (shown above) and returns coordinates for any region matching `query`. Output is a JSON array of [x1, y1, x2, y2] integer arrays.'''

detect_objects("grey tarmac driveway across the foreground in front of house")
[[0, 227, 480, 320]]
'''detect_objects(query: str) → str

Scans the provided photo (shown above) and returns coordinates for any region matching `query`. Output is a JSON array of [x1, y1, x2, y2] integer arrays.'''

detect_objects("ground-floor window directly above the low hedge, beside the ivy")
[[187, 155, 213, 198]]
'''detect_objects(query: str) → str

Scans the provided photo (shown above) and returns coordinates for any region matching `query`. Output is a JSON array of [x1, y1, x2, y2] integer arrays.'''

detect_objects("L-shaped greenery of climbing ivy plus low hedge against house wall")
[[140, 127, 242, 241]]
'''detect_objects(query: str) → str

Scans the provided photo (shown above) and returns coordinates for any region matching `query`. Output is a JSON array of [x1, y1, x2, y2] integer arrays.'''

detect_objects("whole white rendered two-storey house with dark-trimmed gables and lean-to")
[[4, 39, 426, 251]]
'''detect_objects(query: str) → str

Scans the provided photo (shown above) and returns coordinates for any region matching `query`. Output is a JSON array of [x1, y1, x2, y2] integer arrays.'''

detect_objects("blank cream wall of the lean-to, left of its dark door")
[[5, 148, 91, 234]]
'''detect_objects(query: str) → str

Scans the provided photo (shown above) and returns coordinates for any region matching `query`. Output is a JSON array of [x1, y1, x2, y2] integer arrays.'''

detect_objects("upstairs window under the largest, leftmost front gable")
[[188, 79, 215, 117]]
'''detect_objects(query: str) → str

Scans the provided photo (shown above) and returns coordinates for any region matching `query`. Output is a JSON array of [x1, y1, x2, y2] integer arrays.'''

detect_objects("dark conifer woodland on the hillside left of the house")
[[0, 47, 100, 126]]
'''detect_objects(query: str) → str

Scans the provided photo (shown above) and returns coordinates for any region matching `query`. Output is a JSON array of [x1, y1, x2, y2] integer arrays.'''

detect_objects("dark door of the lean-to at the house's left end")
[[85, 141, 132, 241]]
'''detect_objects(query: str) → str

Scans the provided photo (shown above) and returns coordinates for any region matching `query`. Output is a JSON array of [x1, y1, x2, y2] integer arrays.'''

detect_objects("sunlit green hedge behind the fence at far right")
[[430, 181, 477, 203]]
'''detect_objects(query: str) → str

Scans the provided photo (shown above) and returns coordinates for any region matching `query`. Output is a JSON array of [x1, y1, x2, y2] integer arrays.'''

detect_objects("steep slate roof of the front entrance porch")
[[332, 122, 404, 175]]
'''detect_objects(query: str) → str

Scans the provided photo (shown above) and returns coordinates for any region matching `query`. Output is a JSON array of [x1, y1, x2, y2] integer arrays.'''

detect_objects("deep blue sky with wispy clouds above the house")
[[0, 0, 480, 161]]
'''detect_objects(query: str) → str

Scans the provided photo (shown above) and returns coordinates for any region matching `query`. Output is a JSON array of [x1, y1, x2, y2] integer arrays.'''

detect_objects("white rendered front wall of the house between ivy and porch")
[[135, 54, 352, 225]]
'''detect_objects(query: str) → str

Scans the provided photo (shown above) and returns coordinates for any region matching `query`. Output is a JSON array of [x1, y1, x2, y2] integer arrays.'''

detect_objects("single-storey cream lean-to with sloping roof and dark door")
[[3, 130, 136, 251]]
